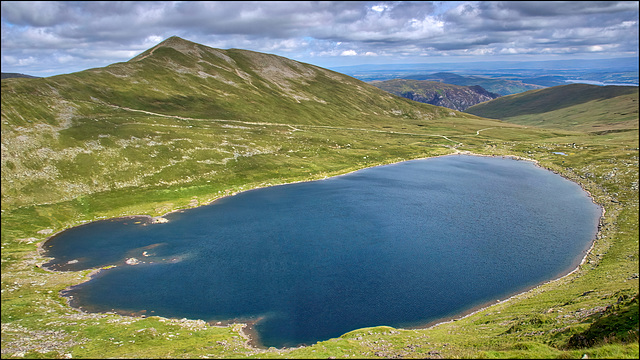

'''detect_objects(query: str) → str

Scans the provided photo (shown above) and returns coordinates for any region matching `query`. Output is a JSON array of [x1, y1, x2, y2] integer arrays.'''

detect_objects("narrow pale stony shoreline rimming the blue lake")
[[37, 150, 605, 350]]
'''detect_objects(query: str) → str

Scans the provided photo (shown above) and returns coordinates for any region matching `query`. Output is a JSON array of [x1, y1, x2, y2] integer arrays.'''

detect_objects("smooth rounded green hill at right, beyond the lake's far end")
[[466, 84, 638, 132]]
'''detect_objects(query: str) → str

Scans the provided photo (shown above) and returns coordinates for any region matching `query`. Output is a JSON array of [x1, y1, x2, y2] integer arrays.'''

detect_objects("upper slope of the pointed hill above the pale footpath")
[[3, 37, 450, 129]]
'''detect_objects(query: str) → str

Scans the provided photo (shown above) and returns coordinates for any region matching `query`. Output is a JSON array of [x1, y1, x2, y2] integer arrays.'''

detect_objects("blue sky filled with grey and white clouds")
[[2, 1, 639, 76]]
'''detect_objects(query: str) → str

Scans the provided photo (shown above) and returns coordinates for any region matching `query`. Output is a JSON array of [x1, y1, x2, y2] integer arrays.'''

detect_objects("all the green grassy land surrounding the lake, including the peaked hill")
[[0, 38, 638, 358]]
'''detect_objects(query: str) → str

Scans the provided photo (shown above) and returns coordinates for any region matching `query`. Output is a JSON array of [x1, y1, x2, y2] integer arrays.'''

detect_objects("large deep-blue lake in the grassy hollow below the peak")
[[45, 155, 601, 347]]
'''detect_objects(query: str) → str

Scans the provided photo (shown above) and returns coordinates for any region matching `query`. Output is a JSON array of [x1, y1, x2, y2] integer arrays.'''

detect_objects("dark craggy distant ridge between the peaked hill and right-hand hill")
[[370, 79, 500, 111]]
